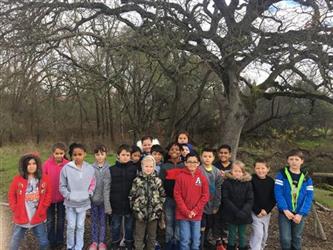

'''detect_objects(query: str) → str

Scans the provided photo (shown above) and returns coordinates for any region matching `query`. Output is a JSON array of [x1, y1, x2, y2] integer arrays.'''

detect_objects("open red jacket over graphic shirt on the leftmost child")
[[8, 175, 52, 225]]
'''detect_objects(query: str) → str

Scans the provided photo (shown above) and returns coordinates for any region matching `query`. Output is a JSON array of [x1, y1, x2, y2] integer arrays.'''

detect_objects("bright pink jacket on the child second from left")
[[43, 155, 68, 203]]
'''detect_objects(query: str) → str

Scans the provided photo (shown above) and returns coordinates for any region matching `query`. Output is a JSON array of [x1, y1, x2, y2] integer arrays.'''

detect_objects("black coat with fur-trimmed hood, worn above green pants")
[[222, 173, 253, 225]]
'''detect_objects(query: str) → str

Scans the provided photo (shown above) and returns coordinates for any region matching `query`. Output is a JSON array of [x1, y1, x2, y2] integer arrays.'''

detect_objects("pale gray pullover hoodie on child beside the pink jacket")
[[59, 161, 96, 210]]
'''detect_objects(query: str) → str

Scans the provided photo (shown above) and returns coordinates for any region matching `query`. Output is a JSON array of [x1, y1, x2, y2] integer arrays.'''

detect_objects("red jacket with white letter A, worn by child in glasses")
[[174, 168, 209, 221]]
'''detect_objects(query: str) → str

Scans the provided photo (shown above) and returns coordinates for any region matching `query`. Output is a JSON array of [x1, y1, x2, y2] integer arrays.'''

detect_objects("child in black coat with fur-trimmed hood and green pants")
[[222, 161, 253, 250]]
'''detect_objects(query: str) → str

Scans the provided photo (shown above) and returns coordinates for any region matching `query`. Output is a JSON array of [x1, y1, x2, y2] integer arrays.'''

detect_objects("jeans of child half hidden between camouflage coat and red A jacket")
[[164, 197, 179, 244]]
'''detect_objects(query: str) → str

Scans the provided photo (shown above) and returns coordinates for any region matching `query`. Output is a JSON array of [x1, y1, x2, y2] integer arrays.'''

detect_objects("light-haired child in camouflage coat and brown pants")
[[129, 155, 165, 250]]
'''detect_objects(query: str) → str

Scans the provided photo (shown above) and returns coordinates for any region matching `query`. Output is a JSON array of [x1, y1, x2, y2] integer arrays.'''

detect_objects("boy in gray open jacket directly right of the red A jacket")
[[200, 148, 222, 249]]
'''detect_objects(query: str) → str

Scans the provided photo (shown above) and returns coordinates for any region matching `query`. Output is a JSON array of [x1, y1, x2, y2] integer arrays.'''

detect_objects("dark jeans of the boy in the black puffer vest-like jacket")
[[111, 214, 134, 243]]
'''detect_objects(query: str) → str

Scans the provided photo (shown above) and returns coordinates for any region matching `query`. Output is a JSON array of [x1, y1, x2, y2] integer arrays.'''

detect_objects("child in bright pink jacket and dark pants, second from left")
[[43, 143, 68, 248]]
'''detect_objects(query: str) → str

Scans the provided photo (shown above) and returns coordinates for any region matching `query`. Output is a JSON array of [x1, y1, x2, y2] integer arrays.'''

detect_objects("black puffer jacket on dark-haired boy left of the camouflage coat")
[[110, 161, 137, 215]]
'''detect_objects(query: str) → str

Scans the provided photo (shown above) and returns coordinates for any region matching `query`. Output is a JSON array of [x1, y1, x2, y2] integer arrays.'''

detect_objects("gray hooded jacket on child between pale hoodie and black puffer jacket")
[[91, 162, 111, 213]]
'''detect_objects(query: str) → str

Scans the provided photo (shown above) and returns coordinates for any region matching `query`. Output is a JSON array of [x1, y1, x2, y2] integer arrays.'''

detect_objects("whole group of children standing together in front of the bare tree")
[[8, 132, 313, 250]]
